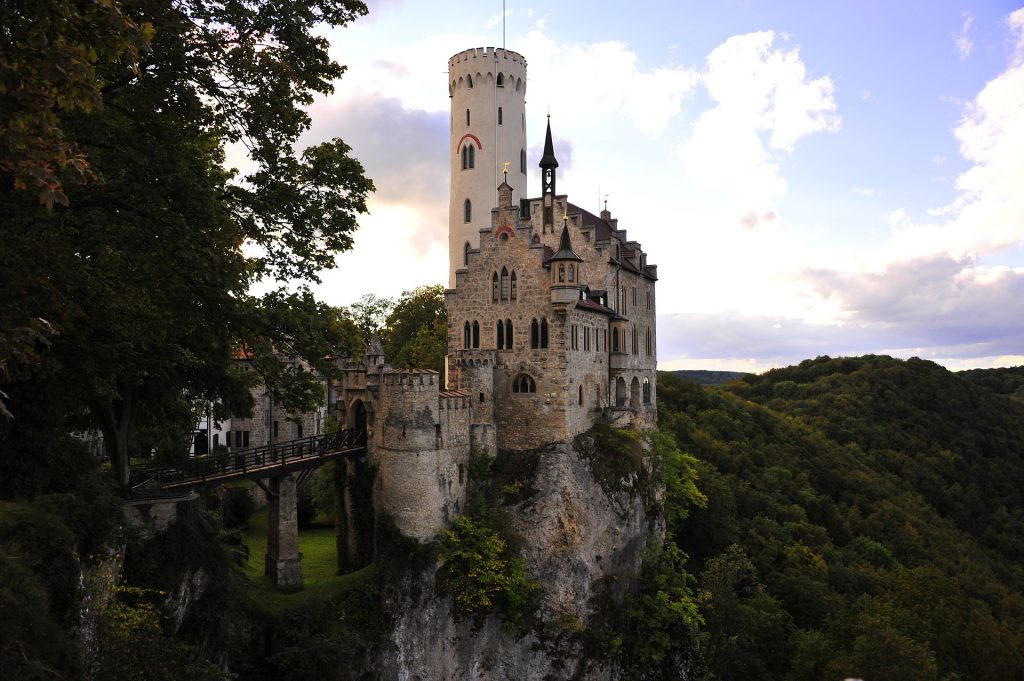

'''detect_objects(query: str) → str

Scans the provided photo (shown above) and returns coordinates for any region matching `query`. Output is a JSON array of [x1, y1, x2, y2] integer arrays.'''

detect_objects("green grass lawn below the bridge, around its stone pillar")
[[243, 508, 373, 614]]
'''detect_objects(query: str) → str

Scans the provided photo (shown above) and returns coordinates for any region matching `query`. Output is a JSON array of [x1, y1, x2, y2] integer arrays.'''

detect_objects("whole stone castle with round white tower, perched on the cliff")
[[329, 47, 657, 554]]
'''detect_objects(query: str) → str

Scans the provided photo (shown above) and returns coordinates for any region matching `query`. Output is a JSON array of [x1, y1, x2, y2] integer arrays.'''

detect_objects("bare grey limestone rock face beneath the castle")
[[377, 443, 664, 681]]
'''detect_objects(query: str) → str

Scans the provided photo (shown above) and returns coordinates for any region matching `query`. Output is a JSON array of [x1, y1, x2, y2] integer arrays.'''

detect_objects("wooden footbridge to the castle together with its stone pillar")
[[132, 430, 367, 591]]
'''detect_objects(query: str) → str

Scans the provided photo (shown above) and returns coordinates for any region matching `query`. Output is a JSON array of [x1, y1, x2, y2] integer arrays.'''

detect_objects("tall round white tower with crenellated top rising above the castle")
[[449, 47, 526, 287]]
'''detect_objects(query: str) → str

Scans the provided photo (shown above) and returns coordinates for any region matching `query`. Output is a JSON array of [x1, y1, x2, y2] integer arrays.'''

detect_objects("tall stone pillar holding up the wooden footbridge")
[[263, 475, 302, 591]]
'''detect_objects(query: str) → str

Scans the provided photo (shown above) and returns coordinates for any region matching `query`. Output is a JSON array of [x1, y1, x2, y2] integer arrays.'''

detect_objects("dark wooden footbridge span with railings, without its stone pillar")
[[138, 430, 367, 486]]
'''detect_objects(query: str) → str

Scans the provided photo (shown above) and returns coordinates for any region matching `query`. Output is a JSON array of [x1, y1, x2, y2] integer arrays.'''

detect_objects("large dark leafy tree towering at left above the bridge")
[[0, 0, 373, 485]]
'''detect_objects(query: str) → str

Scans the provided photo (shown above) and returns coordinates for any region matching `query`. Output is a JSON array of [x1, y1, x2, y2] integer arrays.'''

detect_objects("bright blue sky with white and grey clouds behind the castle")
[[286, 0, 1024, 371]]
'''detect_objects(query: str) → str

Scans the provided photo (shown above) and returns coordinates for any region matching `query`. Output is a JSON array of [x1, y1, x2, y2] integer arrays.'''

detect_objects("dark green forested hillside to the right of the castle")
[[658, 356, 1024, 681]]
